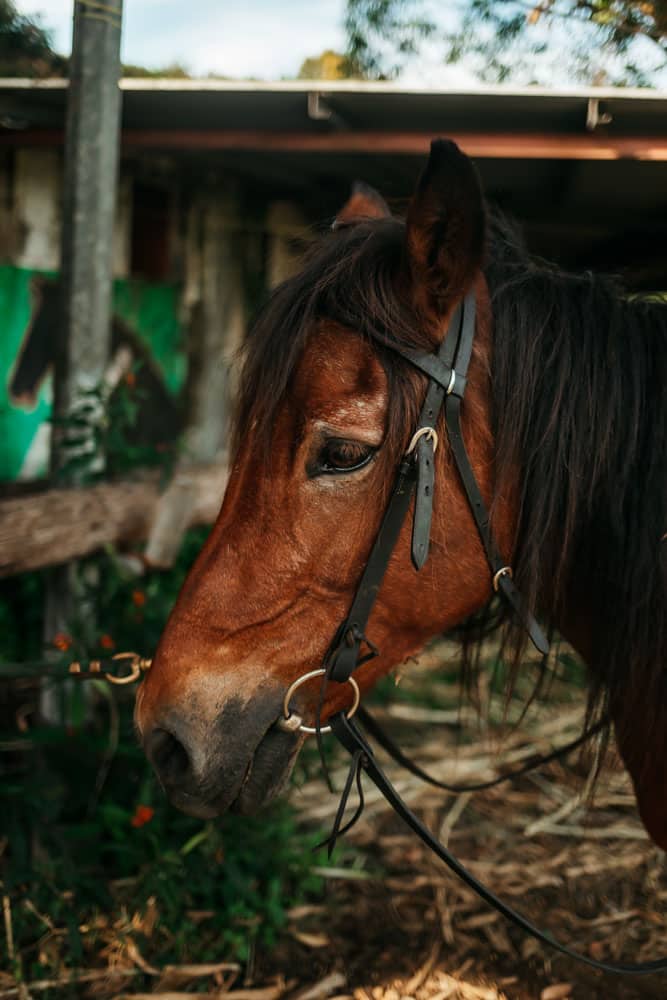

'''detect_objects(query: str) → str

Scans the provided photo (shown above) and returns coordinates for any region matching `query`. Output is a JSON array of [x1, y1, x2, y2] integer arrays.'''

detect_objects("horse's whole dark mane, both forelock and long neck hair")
[[236, 216, 667, 748]]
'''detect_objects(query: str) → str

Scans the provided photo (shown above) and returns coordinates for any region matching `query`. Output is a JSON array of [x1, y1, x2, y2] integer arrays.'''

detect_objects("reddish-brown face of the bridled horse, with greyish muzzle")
[[136, 143, 510, 816]]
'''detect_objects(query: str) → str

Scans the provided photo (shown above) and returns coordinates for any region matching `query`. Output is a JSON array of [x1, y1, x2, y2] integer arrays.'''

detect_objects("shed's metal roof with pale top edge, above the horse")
[[0, 78, 667, 153]]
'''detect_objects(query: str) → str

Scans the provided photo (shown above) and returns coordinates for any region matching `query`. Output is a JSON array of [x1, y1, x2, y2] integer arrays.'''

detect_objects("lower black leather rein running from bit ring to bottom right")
[[329, 713, 667, 976]]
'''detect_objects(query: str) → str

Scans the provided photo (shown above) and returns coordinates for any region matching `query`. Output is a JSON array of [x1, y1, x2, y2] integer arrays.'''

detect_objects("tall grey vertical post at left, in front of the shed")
[[42, 0, 122, 719]]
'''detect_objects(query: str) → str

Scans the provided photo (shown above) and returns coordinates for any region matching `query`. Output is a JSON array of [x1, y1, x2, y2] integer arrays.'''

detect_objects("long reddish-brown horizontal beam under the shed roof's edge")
[[7, 129, 667, 162]]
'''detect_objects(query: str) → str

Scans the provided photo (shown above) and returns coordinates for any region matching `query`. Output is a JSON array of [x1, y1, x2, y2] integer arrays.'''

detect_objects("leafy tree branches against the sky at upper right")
[[345, 0, 667, 85]]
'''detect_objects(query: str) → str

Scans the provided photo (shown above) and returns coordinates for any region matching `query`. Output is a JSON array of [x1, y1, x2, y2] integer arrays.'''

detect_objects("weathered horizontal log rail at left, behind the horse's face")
[[0, 464, 227, 577]]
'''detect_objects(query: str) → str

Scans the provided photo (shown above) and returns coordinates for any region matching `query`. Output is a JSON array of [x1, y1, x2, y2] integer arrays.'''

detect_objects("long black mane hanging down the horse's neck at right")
[[486, 223, 667, 748]]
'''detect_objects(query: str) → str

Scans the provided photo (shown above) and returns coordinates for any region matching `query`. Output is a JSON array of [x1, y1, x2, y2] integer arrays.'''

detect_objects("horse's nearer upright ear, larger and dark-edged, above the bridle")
[[406, 139, 485, 314]]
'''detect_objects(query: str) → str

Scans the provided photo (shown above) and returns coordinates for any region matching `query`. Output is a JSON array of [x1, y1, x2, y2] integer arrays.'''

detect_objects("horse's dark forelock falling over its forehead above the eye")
[[233, 218, 432, 453]]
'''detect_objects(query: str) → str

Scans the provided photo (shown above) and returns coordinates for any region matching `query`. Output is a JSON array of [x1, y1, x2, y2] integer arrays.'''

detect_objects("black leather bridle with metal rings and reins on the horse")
[[278, 291, 667, 975]]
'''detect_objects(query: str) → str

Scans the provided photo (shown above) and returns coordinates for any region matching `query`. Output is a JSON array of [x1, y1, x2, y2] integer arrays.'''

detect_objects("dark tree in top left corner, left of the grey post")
[[0, 0, 67, 77]]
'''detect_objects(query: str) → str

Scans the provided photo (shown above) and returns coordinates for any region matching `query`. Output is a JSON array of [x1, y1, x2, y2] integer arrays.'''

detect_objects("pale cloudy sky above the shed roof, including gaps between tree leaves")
[[14, 0, 667, 88]]
